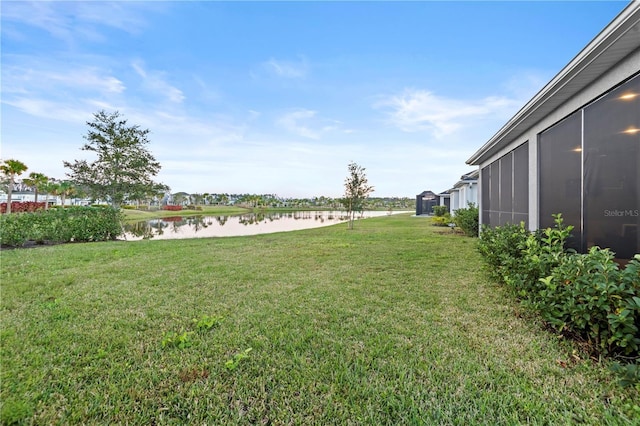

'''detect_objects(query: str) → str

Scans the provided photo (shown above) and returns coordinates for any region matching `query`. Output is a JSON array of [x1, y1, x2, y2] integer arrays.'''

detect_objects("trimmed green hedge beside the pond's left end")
[[0, 207, 122, 247]]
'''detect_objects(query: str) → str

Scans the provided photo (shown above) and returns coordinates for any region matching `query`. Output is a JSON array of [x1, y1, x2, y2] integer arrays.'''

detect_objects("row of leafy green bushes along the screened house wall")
[[479, 214, 640, 358]]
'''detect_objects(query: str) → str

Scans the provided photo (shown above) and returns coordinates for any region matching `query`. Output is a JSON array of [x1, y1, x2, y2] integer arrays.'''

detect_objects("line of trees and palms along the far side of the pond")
[[0, 111, 413, 213]]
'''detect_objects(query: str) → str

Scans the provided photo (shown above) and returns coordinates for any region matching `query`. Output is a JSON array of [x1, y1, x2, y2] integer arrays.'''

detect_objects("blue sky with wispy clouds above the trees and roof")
[[0, 0, 628, 197]]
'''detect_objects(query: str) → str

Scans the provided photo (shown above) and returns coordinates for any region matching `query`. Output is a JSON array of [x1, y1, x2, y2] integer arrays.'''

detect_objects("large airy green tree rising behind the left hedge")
[[64, 111, 160, 207]]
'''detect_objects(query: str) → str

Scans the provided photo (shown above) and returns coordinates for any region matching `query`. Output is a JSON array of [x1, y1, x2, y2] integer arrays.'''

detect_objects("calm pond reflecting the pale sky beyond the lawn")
[[125, 211, 403, 241]]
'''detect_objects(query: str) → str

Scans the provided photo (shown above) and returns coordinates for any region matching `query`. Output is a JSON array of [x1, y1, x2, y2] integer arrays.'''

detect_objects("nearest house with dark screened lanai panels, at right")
[[467, 1, 640, 258]]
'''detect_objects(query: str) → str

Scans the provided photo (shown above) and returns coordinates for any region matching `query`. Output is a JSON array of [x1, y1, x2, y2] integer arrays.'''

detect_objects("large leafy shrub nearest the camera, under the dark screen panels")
[[535, 247, 640, 356]]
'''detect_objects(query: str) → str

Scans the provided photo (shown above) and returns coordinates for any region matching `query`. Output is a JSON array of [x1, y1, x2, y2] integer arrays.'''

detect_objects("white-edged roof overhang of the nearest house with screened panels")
[[467, 1, 640, 165]]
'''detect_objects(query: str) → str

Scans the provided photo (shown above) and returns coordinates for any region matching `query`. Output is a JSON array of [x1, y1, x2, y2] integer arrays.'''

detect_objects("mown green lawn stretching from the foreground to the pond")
[[0, 215, 640, 425]]
